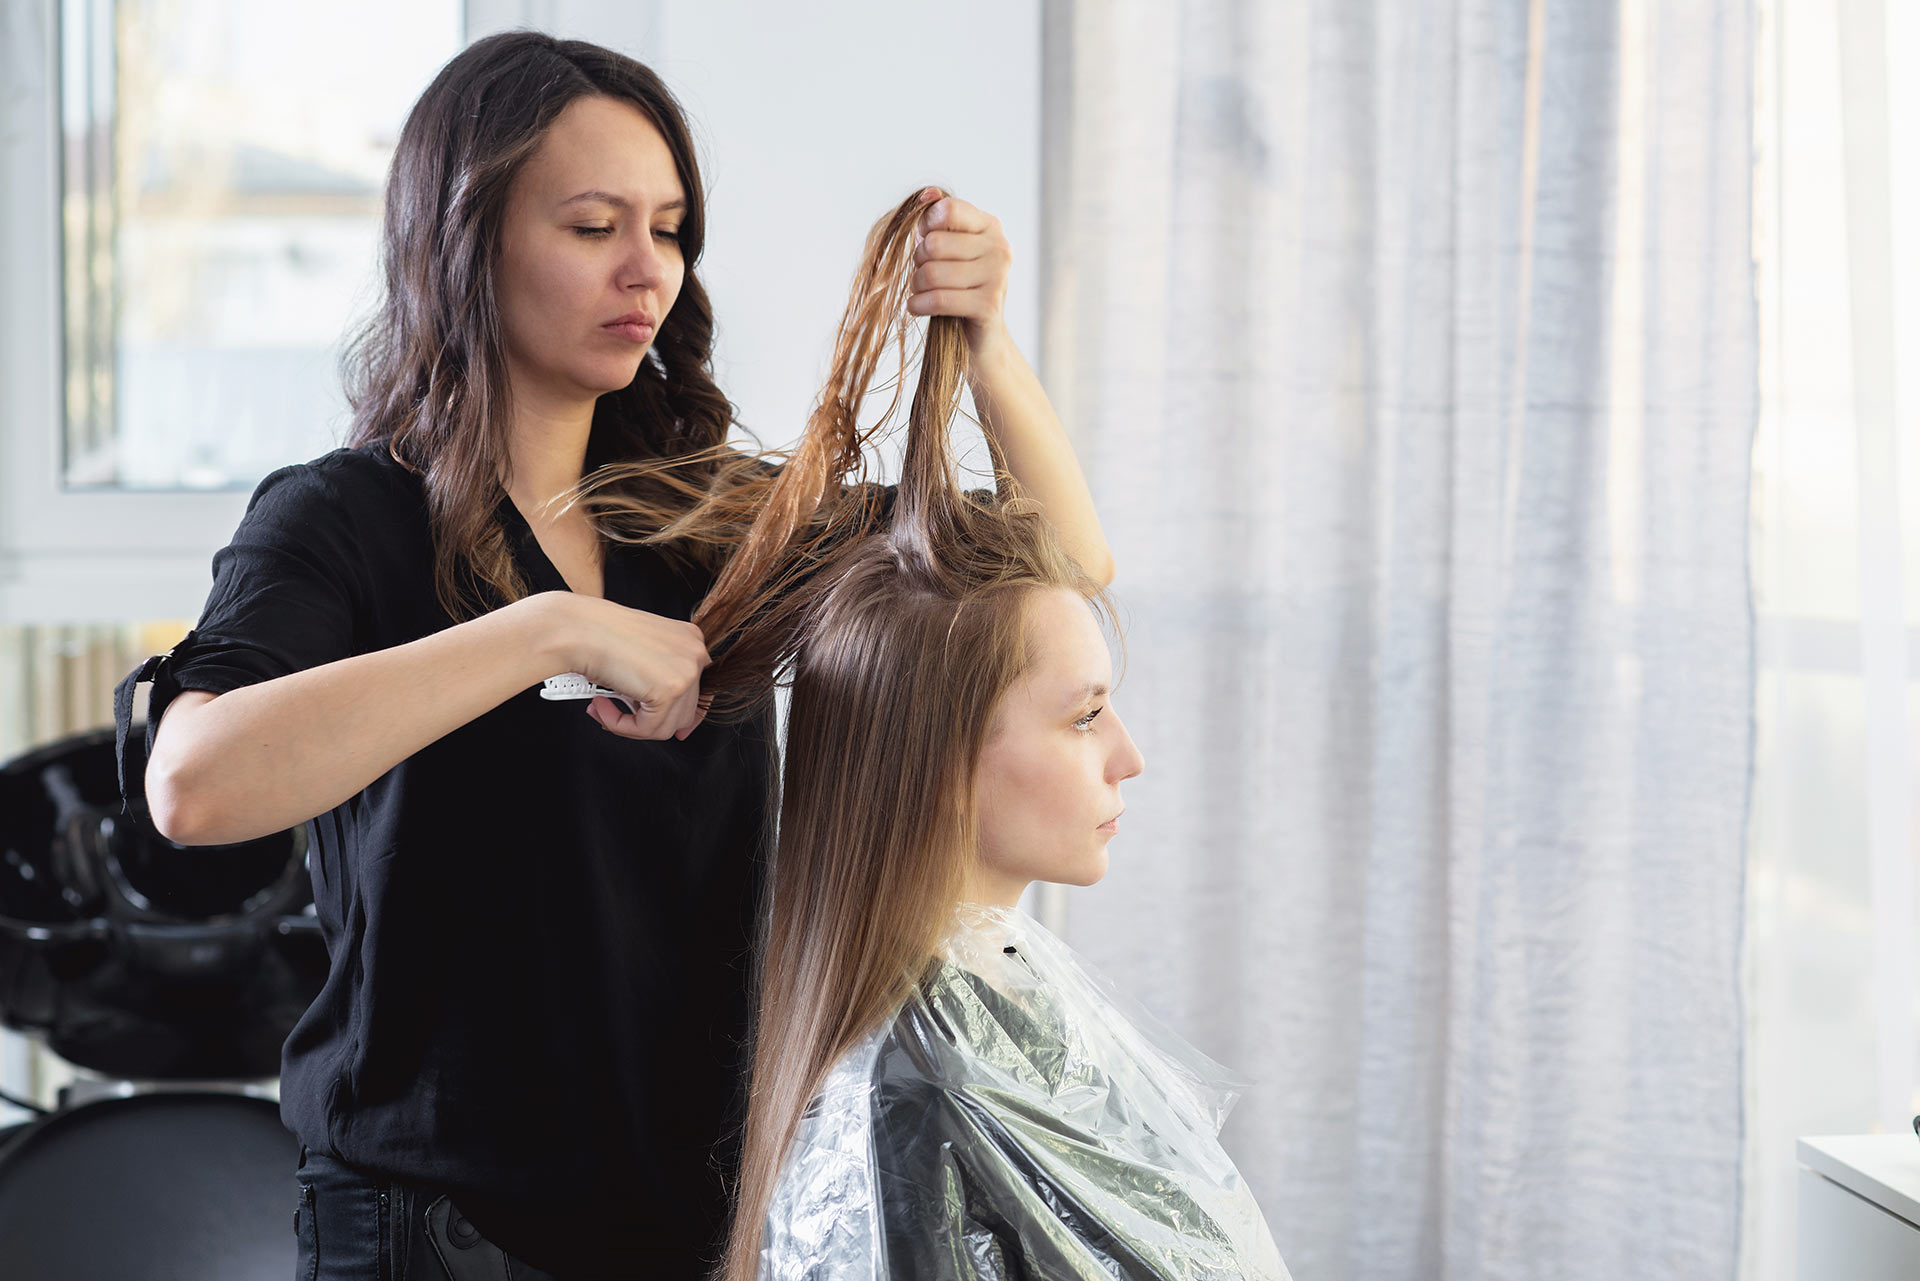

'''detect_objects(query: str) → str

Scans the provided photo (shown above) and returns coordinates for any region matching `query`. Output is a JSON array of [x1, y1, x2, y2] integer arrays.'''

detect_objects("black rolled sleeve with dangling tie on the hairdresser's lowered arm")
[[113, 463, 367, 818]]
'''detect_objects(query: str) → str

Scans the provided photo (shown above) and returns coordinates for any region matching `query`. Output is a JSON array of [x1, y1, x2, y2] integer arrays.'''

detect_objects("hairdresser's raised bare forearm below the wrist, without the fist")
[[968, 336, 1114, 582]]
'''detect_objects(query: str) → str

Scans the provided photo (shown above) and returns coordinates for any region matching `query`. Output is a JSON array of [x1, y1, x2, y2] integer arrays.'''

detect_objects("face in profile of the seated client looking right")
[[968, 588, 1144, 906]]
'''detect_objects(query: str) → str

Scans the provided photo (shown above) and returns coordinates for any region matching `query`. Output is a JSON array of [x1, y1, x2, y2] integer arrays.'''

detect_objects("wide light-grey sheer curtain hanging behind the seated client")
[[1044, 0, 1757, 1281]]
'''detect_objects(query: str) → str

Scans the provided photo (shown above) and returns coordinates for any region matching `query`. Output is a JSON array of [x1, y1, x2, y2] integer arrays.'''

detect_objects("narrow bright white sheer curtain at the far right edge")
[[1743, 0, 1920, 1281]]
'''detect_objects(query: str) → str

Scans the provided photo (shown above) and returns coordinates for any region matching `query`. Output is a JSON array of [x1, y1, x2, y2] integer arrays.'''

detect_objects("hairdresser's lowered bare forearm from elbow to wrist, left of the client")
[[146, 595, 564, 845]]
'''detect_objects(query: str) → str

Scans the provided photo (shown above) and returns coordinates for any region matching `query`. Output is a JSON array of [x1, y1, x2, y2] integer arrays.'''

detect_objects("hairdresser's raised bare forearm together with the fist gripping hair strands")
[[906, 196, 1114, 582]]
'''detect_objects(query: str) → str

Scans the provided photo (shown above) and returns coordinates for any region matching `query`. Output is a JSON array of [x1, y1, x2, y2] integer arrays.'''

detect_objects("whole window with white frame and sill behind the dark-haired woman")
[[0, 0, 476, 624]]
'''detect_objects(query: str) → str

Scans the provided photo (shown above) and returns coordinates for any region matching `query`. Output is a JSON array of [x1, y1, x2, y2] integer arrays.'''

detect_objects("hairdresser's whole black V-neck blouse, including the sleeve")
[[121, 446, 774, 1277]]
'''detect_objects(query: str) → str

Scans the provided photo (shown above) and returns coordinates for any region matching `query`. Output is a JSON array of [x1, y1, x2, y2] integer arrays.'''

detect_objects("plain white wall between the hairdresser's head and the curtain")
[[503, 0, 1041, 470]]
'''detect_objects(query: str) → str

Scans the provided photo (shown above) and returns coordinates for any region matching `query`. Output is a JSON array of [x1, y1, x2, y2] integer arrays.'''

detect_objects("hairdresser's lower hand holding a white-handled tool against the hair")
[[555, 593, 712, 739]]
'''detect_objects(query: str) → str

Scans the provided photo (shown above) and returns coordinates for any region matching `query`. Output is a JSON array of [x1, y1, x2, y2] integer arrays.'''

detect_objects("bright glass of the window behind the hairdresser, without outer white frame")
[[60, 0, 465, 488]]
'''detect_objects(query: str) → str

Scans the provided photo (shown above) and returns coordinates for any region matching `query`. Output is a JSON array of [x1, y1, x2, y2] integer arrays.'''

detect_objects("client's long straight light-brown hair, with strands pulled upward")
[[560, 185, 1110, 1281]]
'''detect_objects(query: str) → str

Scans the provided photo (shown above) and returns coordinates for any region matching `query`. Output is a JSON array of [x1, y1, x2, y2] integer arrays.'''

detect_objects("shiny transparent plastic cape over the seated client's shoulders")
[[760, 905, 1288, 1281]]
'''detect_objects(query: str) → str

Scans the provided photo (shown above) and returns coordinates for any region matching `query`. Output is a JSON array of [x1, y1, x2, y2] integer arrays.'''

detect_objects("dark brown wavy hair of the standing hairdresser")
[[342, 31, 733, 618]]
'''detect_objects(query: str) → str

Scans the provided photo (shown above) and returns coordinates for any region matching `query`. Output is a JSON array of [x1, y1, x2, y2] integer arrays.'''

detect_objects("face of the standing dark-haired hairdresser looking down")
[[495, 98, 685, 409]]
